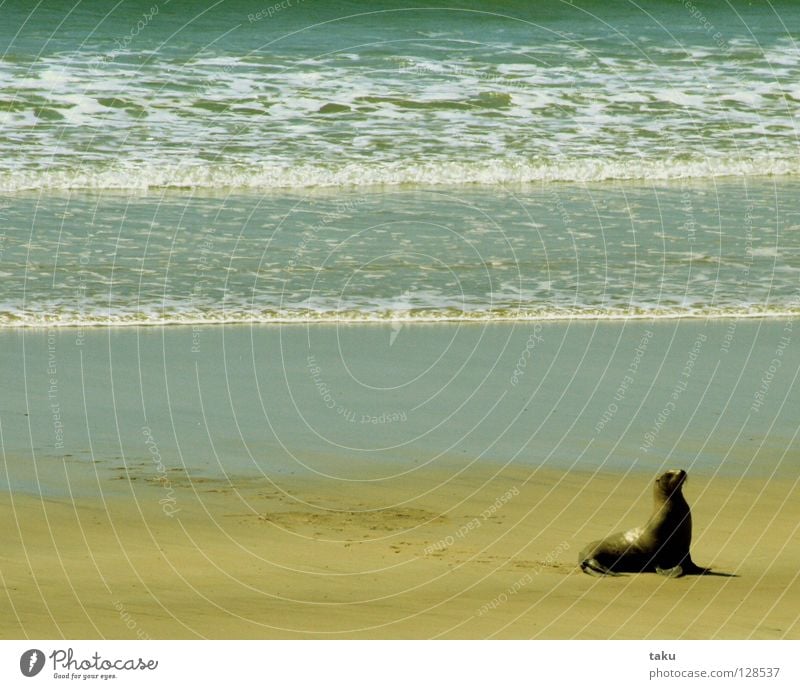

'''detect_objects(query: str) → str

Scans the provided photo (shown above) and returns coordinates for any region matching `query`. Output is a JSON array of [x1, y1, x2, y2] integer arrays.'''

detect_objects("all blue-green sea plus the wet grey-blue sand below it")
[[0, 0, 800, 495]]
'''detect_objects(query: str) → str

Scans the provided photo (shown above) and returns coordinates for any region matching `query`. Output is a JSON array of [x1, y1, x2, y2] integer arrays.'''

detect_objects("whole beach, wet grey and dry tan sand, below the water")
[[0, 319, 800, 639]]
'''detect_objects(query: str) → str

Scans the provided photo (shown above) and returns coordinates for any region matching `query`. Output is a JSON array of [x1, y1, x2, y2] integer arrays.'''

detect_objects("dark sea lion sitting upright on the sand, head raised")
[[578, 469, 708, 577]]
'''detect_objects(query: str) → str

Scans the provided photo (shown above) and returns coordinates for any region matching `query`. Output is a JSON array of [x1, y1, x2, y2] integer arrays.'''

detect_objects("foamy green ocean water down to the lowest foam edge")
[[0, 0, 800, 327]]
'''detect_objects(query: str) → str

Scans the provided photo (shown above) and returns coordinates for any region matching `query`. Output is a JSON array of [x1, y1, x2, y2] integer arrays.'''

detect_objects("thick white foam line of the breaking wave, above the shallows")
[[0, 157, 800, 193]]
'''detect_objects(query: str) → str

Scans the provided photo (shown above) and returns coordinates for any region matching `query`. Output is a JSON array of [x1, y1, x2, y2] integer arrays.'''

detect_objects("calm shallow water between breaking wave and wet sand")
[[0, 178, 800, 326]]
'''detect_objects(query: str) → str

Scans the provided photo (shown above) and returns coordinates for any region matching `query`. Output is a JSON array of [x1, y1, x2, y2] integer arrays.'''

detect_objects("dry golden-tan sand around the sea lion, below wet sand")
[[0, 466, 800, 639]]
